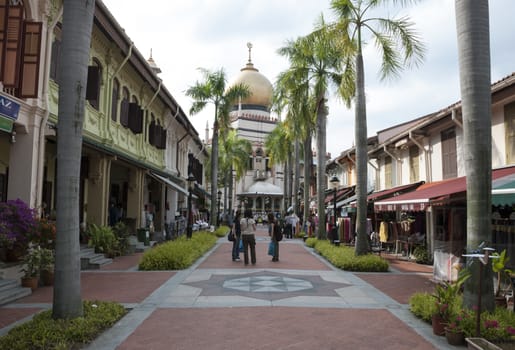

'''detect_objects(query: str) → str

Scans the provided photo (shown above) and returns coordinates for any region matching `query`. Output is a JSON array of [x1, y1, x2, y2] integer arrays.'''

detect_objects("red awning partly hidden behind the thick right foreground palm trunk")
[[374, 166, 515, 211]]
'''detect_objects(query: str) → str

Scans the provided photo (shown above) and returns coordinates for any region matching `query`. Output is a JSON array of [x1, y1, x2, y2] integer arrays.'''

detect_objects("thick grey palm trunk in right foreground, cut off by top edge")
[[456, 0, 495, 311]]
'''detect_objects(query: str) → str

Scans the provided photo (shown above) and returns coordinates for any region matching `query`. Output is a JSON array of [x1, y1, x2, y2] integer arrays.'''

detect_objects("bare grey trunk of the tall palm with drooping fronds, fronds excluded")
[[354, 53, 370, 255]]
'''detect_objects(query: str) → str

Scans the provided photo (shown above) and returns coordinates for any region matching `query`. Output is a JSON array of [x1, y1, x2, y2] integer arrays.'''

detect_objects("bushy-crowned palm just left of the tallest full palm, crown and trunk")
[[279, 17, 345, 239]]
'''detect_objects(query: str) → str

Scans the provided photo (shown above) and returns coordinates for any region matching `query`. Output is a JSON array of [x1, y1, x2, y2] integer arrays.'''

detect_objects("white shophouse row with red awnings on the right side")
[[328, 74, 515, 278]]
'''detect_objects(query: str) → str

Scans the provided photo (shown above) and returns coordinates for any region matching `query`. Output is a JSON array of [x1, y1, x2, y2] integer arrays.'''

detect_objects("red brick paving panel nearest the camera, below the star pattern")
[[117, 307, 434, 350]]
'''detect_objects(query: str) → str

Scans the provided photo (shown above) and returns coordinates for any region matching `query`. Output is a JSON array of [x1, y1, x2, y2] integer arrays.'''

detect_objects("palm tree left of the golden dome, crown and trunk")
[[186, 68, 250, 225]]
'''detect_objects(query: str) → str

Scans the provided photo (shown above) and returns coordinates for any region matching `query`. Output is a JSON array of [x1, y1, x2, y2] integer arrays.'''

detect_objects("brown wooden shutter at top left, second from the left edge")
[[20, 22, 42, 98]]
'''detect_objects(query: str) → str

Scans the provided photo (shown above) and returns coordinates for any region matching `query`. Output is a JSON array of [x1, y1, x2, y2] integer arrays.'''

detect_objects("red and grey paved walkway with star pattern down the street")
[[0, 227, 460, 350]]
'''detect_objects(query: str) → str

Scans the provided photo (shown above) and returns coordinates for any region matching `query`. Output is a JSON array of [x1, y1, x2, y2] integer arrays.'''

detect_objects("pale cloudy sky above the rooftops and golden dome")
[[103, 0, 515, 158]]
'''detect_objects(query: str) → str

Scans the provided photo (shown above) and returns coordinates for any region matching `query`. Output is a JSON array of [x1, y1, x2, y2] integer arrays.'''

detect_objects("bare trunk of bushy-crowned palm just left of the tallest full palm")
[[316, 94, 327, 239]]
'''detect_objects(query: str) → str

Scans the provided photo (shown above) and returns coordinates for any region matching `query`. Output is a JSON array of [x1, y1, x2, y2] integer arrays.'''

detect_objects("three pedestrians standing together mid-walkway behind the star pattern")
[[231, 209, 282, 265]]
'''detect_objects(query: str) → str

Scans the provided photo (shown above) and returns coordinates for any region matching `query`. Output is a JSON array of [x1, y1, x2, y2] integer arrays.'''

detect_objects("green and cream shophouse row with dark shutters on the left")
[[0, 0, 207, 238]]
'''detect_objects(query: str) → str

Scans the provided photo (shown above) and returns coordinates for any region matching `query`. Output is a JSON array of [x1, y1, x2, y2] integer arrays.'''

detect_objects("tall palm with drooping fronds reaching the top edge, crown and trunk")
[[331, 0, 424, 255]]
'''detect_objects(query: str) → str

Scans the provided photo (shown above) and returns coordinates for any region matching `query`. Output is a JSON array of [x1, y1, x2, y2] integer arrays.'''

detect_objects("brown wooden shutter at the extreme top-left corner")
[[0, 5, 23, 88]]
